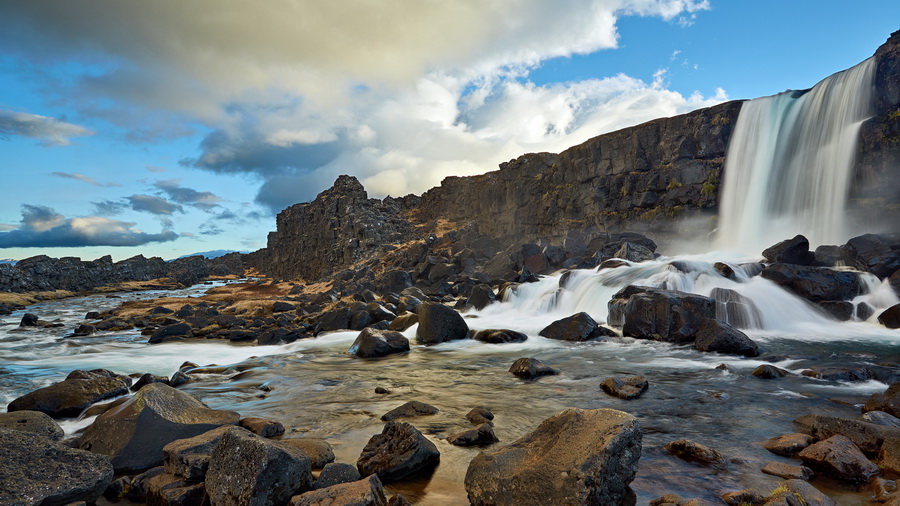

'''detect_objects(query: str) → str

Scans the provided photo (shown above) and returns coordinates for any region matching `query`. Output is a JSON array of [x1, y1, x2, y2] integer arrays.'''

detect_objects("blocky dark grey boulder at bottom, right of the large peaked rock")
[[206, 430, 312, 505]]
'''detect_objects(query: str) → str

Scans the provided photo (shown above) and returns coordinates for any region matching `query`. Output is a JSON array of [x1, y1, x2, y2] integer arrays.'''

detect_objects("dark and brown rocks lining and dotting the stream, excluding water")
[[0, 227, 900, 505]]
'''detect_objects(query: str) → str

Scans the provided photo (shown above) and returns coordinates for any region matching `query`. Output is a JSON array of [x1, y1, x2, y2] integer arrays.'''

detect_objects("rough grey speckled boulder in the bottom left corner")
[[0, 428, 113, 505]]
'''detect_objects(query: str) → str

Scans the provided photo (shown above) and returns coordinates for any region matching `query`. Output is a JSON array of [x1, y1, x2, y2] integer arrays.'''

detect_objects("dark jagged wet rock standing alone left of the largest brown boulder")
[[356, 422, 441, 483]]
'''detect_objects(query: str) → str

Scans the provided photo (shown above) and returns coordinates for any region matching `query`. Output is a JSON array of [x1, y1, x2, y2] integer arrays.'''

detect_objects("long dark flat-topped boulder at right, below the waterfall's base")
[[761, 264, 860, 302]]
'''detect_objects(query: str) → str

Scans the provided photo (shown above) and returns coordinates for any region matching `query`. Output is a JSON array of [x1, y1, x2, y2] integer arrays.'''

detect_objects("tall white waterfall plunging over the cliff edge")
[[717, 58, 875, 254]]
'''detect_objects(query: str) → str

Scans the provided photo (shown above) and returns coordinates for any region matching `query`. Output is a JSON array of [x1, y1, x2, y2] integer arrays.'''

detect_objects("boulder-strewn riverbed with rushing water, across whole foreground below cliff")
[[0, 233, 900, 504]]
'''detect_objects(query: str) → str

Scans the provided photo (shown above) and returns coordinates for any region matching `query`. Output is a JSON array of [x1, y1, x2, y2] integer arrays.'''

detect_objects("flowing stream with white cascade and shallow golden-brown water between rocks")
[[0, 254, 900, 504]]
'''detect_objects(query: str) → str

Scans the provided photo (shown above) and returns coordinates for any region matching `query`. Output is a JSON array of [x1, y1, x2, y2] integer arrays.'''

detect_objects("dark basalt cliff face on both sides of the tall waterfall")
[[253, 32, 900, 280]]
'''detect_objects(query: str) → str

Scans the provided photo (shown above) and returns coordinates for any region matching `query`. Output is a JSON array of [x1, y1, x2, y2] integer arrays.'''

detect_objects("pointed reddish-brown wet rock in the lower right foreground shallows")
[[797, 435, 878, 482]]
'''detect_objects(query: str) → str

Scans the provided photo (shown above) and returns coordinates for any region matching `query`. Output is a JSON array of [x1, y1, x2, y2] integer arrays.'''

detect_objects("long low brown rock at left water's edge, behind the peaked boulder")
[[6, 375, 131, 418]]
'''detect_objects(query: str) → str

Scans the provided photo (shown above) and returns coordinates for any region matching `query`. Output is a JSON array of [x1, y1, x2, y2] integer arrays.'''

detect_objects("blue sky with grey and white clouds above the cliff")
[[0, 0, 900, 260]]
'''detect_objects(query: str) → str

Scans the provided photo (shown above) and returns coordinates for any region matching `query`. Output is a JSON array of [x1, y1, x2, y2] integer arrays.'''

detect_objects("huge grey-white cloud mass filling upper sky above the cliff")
[[0, 0, 726, 211]]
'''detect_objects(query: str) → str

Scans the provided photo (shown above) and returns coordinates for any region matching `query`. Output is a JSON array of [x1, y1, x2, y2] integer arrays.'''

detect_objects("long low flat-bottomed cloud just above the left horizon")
[[0, 204, 178, 248]]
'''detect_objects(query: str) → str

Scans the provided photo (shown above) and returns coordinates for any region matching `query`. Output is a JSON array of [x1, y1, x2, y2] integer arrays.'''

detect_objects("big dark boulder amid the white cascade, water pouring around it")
[[610, 288, 716, 343]]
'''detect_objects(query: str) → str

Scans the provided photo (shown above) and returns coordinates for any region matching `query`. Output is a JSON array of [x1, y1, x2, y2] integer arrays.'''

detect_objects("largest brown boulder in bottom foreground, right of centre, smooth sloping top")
[[465, 409, 641, 505]]
